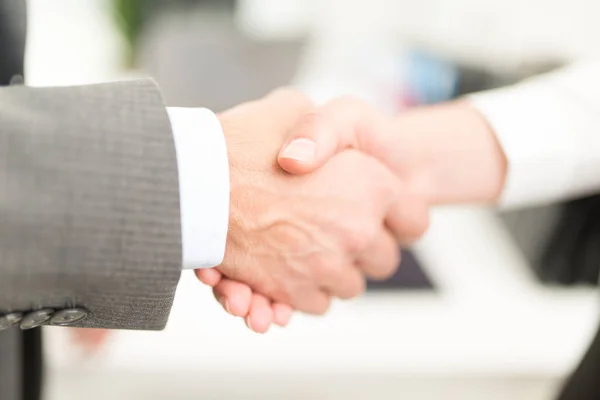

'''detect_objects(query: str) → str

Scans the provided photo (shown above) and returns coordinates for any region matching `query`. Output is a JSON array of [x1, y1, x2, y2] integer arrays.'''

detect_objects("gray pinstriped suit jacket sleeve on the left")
[[0, 80, 181, 329]]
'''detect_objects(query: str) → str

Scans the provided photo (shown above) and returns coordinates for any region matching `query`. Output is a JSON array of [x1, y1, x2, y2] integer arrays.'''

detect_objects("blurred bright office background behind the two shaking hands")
[[12, 0, 600, 400]]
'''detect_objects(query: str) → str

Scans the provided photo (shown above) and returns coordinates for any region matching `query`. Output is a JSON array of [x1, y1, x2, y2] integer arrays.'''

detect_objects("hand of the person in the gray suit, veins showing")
[[199, 92, 426, 332]]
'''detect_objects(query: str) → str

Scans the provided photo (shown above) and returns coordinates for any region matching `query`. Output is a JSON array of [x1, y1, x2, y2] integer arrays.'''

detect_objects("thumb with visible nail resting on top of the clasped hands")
[[278, 97, 387, 174]]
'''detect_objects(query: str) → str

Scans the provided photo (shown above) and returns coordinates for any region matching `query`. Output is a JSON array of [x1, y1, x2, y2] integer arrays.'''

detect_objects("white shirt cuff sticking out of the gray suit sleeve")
[[167, 107, 229, 269]]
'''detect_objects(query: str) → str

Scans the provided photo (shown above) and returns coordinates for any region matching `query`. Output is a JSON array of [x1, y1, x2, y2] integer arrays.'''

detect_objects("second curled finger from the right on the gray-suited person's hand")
[[356, 229, 400, 280]]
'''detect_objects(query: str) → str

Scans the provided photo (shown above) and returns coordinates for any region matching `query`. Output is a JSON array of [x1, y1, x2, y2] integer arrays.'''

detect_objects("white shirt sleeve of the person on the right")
[[470, 61, 600, 207]]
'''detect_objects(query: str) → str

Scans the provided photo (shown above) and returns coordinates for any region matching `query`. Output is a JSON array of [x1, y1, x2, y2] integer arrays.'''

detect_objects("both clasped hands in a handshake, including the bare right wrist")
[[196, 89, 505, 333]]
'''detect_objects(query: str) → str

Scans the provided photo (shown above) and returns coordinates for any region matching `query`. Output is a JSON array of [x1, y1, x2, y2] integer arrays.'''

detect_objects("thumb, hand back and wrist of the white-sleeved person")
[[278, 97, 507, 203]]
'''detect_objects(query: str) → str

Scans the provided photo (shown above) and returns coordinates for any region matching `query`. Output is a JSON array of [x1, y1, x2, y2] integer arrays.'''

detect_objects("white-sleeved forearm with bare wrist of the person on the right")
[[390, 63, 600, 207]]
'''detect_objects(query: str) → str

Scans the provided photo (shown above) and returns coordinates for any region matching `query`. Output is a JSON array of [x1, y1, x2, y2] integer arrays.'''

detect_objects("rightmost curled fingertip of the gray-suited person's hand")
[[385, 193, 429, 246]]
